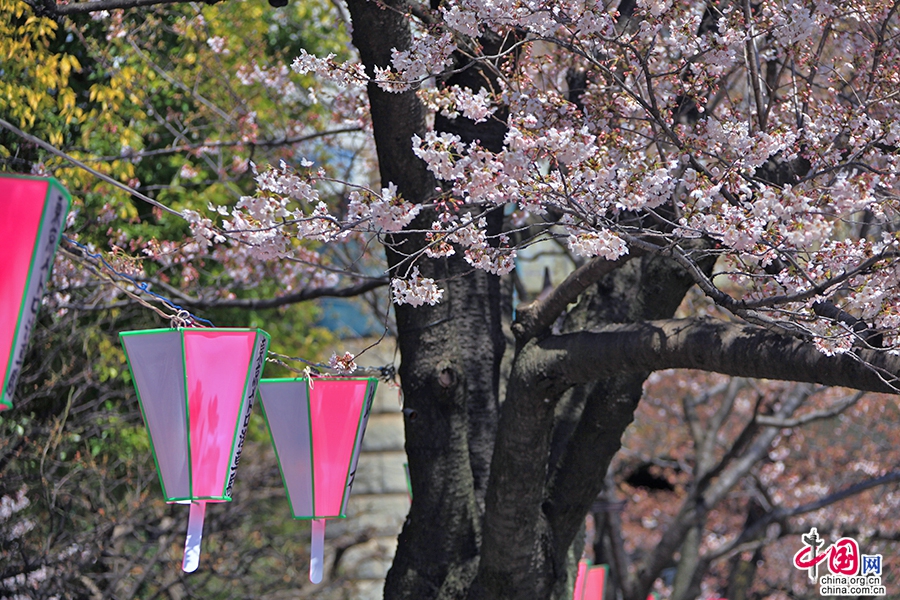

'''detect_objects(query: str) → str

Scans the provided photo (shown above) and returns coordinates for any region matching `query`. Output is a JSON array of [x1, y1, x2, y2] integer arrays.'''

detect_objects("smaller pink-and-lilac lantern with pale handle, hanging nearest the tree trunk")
[[259, 377, 378, 583]]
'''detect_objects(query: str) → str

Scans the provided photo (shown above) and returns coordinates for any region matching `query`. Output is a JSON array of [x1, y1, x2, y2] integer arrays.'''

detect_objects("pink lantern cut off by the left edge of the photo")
[[0, 175, 71, 411]]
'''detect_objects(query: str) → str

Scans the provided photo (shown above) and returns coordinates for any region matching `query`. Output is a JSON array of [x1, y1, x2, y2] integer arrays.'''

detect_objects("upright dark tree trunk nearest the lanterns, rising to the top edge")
[[348, 0, 505, 600]]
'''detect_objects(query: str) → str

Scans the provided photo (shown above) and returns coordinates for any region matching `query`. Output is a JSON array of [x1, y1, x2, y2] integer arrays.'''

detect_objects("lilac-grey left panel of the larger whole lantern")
[[120, 329, 191, 502]]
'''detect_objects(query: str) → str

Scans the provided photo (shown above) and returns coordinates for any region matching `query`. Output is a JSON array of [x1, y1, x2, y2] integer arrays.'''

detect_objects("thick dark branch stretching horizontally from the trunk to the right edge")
[[520, 318, 900, 397]]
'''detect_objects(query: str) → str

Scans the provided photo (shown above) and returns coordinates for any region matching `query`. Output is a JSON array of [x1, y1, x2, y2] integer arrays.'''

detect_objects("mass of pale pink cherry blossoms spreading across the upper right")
[[148, 0, 900, 352]]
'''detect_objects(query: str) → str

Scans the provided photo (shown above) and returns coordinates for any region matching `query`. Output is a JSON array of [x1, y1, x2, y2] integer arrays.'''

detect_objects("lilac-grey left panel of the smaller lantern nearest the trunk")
[[260, 379, 316, 519]]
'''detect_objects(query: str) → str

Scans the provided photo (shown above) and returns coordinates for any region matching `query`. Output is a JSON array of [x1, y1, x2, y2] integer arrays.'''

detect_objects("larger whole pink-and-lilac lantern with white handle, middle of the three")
[[119, 328, 269, 572]]
